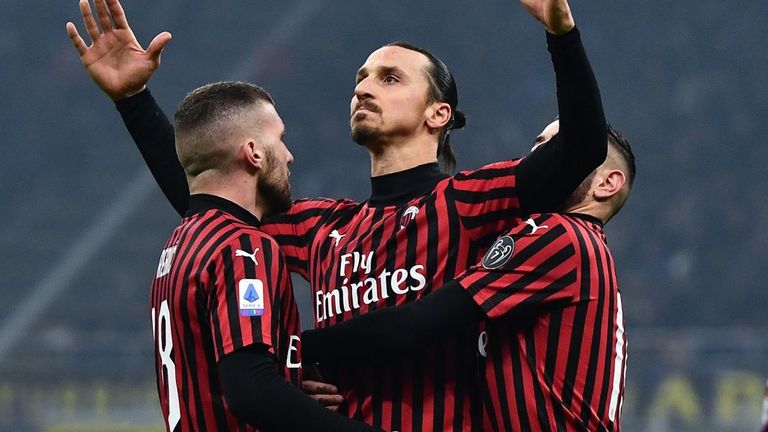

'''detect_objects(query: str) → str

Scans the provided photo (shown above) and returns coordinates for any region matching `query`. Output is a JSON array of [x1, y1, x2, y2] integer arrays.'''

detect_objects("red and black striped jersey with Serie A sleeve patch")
[[150, 195, 301, 431]]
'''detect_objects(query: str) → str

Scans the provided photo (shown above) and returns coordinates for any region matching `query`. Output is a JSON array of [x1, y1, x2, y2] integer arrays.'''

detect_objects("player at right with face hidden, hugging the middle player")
[[302, 122, 635, 431]]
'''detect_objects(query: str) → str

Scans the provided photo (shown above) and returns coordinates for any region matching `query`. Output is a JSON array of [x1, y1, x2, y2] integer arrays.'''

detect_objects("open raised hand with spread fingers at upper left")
[[67, 0, 171, 100]]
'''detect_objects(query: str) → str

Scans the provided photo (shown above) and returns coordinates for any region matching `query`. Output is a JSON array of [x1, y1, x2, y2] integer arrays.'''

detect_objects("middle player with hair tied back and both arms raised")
[[63, 0, 620, 431]]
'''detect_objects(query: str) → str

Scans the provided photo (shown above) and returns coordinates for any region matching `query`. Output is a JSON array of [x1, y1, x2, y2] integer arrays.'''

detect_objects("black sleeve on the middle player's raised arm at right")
[[517, 28, 608, 215]]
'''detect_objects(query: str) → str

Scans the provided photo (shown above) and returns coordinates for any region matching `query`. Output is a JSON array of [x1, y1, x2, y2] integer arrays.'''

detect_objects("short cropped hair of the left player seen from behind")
[[173, 81, 275, 176]]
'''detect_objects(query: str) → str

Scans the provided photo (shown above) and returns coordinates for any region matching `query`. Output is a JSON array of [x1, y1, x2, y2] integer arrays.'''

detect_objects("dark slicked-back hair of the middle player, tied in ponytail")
[[387, 42, 467, 172]]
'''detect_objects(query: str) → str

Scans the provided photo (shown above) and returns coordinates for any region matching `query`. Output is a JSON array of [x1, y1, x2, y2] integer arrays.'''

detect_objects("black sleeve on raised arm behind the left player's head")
[[115, 90, 189, 216]]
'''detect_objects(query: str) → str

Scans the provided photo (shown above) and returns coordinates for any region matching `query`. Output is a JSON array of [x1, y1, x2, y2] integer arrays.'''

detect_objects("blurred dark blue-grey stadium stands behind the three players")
[[0, 0, 768, 432]]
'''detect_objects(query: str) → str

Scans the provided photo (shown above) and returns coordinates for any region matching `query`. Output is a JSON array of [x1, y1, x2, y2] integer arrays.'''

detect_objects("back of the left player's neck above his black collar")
[[187, 173, 264, 219]]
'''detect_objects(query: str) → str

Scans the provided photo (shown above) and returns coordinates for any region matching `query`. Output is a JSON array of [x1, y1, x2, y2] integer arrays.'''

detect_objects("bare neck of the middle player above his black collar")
[[366, 135, 437, 177]]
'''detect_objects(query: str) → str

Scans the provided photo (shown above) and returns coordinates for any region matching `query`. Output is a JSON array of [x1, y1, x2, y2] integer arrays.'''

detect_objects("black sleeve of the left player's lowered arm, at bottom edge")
[[218, 346, 380, 432]]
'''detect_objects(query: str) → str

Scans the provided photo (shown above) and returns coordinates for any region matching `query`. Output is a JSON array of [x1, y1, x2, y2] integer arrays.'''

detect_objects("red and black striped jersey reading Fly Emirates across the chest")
[[263, 160, 519, 432]]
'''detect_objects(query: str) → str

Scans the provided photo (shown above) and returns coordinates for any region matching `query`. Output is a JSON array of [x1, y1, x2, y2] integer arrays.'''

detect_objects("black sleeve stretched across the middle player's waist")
[[301, 282, 485, 363]]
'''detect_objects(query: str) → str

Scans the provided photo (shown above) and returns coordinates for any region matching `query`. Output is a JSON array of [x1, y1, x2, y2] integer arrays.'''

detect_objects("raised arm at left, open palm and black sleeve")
[[67, 0, 189, 214]]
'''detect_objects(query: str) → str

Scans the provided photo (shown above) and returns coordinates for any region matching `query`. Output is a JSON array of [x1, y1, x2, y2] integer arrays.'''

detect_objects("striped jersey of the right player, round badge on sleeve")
[[457, 214, 627, 431]]
